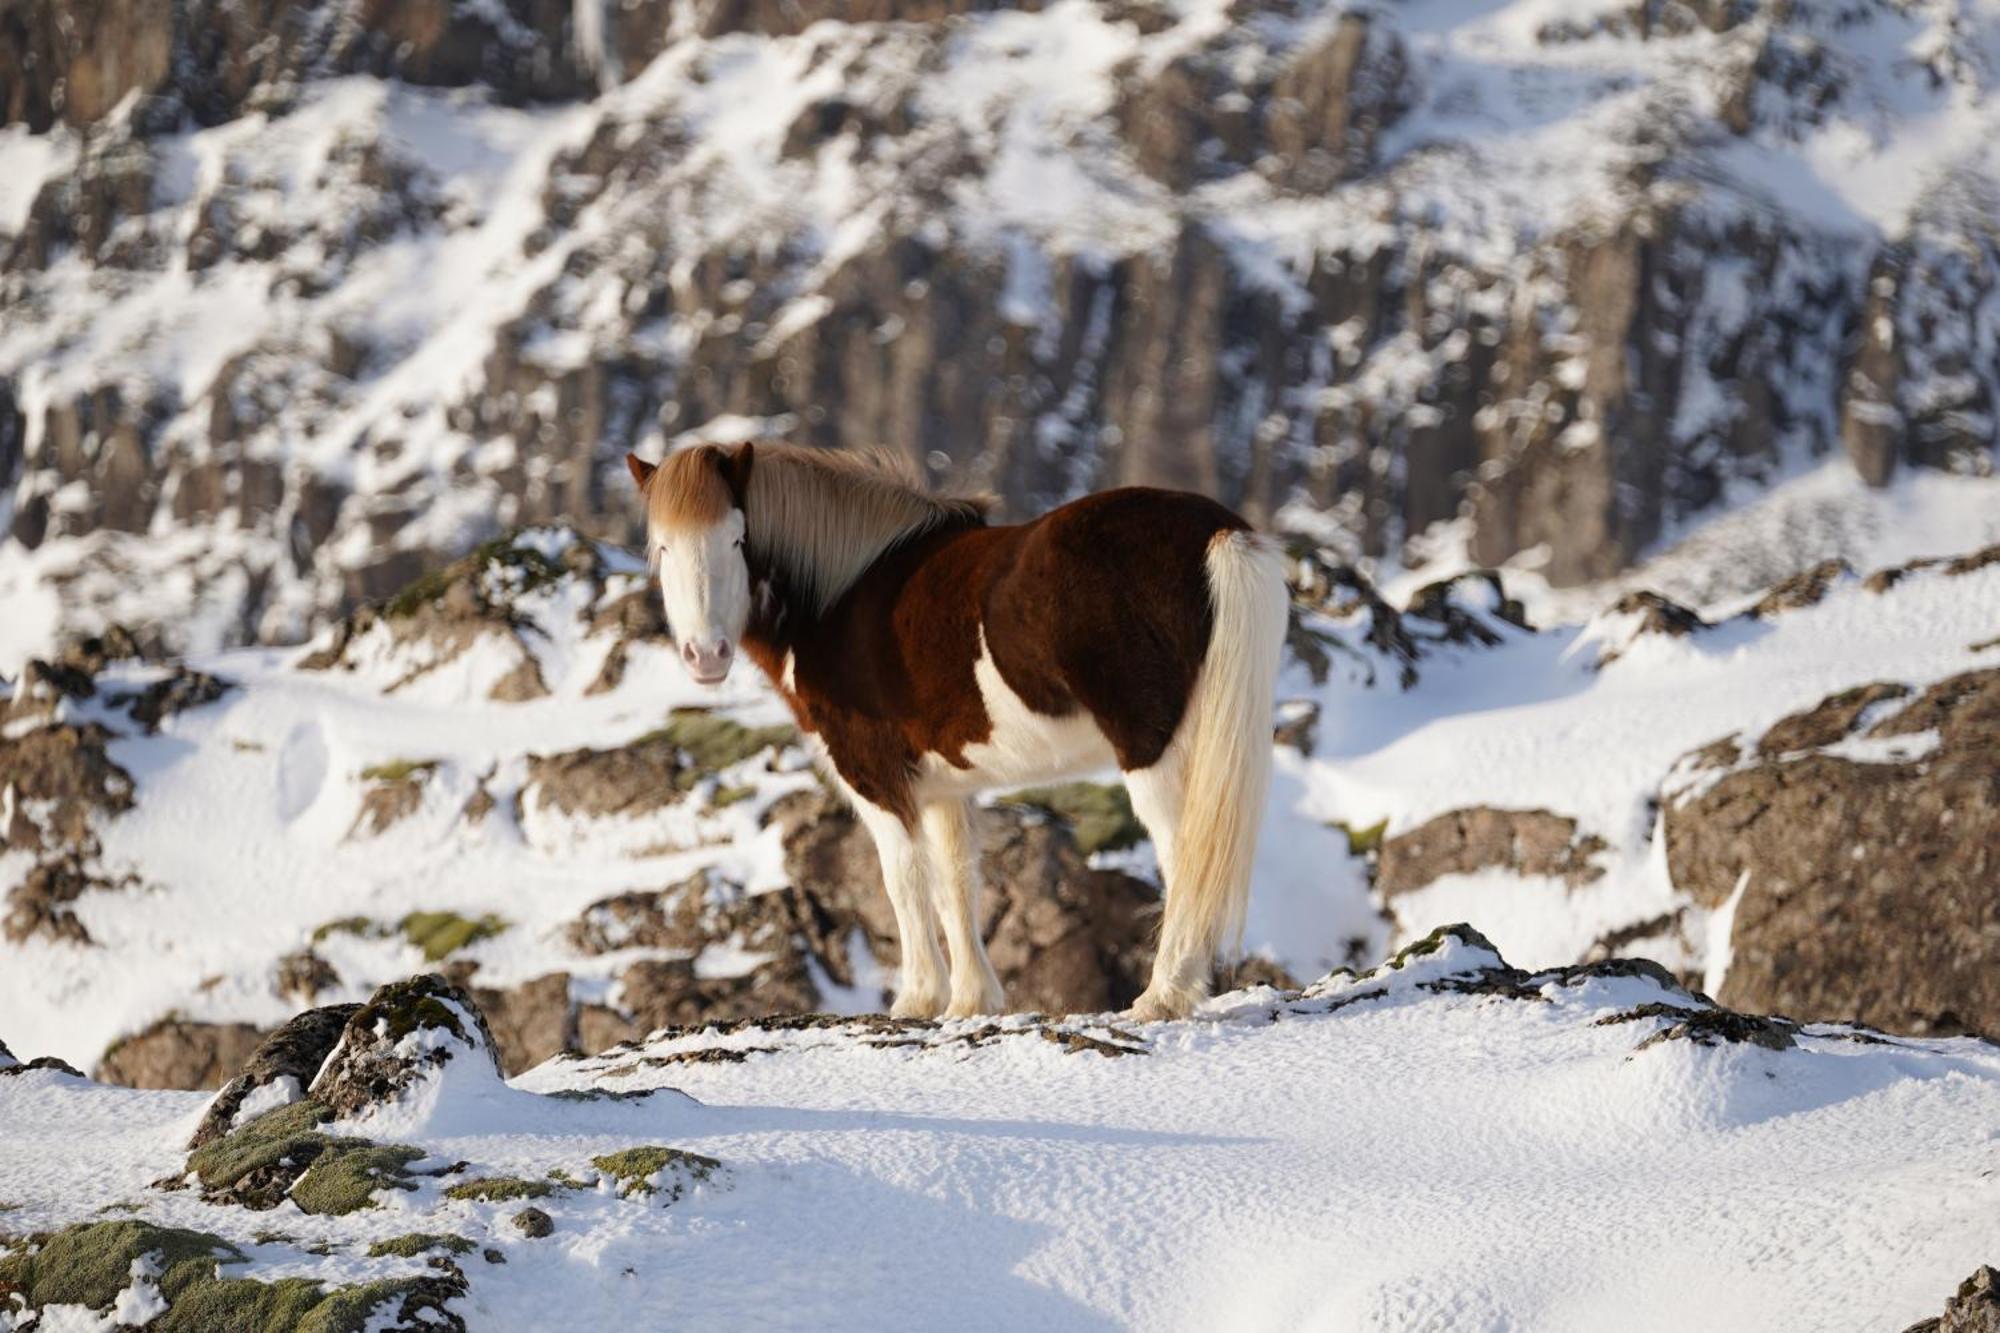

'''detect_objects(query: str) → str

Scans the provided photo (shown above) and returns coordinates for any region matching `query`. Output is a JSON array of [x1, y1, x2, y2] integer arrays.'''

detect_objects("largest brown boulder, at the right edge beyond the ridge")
[[1664, 671, 2000, 1035]]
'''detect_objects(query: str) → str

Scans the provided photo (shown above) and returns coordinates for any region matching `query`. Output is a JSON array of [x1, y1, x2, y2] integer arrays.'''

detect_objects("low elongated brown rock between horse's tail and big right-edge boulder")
[[1374, 805, 1604, 899]]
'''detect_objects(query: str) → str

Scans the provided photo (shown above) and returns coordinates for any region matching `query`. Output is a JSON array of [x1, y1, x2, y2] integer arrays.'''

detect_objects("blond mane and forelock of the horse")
[[646, 444, 992, 614]]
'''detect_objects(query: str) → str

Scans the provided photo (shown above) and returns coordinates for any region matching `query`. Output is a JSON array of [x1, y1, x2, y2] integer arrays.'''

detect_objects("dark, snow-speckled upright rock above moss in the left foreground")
[[312, 975, 500, 1119]]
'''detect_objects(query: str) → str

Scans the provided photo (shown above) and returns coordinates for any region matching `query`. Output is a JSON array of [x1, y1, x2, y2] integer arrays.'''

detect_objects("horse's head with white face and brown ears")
[[626, 444, 752, 685]]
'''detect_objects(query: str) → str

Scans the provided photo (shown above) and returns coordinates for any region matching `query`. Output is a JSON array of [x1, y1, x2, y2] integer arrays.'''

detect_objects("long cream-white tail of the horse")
[[1150, 532, 1288, 1013]]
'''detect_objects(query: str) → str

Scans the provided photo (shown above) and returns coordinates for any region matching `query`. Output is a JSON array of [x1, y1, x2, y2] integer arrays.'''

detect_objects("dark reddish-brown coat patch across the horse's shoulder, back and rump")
[[744, 488, 1248, 821]]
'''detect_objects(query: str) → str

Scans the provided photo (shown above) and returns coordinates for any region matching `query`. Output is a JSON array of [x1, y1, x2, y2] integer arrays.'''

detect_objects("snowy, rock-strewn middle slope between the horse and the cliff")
[[0, 504, 2000, 1087]]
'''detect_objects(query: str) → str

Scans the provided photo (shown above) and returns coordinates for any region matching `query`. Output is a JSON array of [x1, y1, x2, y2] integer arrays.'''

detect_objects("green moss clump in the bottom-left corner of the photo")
[[0, 1221, 244, 1309]]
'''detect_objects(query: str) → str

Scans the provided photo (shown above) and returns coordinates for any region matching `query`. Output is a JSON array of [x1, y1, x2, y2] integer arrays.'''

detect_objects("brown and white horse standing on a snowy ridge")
[[626, 442, 1288, 1021]]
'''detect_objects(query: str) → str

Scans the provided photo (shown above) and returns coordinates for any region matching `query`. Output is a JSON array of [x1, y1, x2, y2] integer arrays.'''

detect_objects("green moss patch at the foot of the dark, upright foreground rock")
[[188, 1097, 424, 1215]]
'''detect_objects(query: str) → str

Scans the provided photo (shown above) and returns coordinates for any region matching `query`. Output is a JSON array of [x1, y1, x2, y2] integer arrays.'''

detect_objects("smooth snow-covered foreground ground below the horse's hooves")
[[0, 924, 2000, 1333]]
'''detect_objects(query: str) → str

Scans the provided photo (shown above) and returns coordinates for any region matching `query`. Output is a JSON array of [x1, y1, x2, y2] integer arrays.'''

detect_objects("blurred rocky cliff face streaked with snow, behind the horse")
[[0, 0, 2000, 642]]
